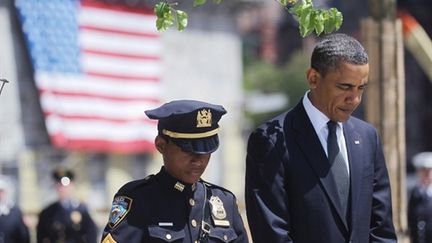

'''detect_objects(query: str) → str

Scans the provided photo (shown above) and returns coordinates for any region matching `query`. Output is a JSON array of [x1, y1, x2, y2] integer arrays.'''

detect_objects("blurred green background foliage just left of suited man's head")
[[244, 51, 309, 127]]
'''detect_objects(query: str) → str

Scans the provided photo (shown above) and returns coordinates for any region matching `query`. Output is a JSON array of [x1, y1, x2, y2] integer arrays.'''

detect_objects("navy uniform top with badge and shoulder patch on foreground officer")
[[102, 167, 248, 243]]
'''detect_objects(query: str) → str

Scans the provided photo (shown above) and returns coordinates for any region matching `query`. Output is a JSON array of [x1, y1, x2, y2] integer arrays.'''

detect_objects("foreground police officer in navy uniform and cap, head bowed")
[[102, 100, 248, 243]]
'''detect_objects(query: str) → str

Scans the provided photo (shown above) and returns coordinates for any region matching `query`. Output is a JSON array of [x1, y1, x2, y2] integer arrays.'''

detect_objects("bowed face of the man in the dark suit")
[[307, 63, 369, 122]]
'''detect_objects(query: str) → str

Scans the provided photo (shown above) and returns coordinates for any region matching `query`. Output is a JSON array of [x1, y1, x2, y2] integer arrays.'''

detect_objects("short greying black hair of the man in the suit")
[[311, 33, 369, 76]]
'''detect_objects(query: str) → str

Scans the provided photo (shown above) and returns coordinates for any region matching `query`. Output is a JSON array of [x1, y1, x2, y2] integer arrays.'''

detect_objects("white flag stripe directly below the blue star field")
[[36, 72, 161, 99]]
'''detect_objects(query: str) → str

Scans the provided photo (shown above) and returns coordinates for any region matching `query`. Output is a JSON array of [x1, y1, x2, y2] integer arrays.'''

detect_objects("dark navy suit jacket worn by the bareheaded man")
[[246, 102, 396, 243]]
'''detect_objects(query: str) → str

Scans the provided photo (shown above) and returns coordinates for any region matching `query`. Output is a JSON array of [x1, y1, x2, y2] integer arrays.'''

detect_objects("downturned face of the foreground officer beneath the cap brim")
[[155, 136, 210, 184]]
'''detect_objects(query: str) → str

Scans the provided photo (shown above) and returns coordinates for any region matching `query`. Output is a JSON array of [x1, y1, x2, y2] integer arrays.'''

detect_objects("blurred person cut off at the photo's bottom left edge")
[[0, 175, 30, 243]]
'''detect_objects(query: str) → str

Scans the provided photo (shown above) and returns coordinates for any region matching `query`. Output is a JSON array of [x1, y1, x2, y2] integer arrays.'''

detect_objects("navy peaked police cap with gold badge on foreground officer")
[[145, 100, 226, 154]]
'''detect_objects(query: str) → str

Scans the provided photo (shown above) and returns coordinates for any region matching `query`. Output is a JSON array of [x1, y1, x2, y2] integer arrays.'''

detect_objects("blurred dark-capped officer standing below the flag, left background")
[[36, 167, 97, 243]]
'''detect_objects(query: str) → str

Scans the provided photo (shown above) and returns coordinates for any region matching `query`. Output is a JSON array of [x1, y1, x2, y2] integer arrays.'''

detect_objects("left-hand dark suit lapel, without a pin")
[[293, 102, 348, 229]]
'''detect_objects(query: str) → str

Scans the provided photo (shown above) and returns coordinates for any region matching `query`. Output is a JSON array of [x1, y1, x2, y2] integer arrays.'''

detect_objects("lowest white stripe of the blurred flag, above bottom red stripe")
[[46, 116, 157, 142]]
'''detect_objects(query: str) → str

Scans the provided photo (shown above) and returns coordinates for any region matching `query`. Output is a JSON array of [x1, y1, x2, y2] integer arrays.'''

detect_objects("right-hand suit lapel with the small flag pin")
[[344, 120, 364, 232]]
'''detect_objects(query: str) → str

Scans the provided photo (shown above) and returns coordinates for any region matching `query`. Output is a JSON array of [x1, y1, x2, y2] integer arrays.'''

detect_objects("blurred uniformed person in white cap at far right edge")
[[408, 152, 432, 243]]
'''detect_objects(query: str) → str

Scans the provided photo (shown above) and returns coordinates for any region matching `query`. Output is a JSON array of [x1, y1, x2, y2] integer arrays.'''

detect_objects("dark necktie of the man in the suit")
[[327, 121, 350, 216]]
